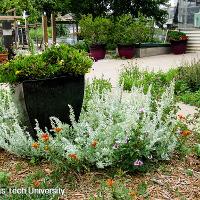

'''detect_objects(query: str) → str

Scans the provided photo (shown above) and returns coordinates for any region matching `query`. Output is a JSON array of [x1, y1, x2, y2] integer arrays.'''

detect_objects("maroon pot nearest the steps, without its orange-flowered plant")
[[170, 40, 187, 54]]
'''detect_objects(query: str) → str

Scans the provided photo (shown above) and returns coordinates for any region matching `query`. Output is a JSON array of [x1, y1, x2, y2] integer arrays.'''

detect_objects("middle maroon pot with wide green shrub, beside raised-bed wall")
[[113, 14, 153, 59]]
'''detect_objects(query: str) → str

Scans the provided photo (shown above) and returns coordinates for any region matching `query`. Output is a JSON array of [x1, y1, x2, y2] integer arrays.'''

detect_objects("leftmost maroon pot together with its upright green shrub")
[[79, 15, 112, 60]]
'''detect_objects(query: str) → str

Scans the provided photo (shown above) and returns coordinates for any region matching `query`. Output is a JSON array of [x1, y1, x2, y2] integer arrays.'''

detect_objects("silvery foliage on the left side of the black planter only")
[[0, 84, 37, 156]]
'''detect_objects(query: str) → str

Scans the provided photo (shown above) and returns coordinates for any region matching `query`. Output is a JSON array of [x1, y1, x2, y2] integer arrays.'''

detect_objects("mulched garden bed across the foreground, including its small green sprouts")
[[0, 145, 200, 200]]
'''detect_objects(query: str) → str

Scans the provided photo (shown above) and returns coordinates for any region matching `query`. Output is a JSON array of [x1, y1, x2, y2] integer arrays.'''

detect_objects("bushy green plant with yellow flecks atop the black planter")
[[0, 44, 93, 83]]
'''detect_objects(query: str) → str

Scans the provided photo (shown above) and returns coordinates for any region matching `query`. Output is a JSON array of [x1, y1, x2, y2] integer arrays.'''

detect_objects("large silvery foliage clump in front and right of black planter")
[[36, 84, 178, 168]]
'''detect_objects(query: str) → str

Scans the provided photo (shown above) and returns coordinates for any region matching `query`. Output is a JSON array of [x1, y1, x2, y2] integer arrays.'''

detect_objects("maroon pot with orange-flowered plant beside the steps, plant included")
[[168, 31, 188, 54]]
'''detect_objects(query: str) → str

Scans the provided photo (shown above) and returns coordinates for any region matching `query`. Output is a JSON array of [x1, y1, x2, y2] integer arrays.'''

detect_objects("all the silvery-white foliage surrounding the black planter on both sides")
[[0, 84, 178, 168]]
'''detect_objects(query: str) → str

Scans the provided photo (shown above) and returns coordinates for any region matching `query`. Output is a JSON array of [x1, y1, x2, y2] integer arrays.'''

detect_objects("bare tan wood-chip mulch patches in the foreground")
[[0, 150, 200, 200]]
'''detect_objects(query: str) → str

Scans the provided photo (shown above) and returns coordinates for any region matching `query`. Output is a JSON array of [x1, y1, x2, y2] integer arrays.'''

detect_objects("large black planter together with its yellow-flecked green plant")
[[0, 44, 93, 138]]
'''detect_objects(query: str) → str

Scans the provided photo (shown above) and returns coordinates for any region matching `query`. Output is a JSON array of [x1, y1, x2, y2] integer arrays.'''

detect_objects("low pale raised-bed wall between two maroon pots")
[[135, 43, 171, 58]]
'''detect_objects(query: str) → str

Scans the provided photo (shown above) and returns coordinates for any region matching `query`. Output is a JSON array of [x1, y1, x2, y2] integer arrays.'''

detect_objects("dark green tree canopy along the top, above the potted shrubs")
[[69, 0, 168, 23]]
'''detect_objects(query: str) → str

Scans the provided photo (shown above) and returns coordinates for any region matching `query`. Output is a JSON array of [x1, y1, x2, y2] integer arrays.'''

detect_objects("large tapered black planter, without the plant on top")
[[15, 75, 84, 138]]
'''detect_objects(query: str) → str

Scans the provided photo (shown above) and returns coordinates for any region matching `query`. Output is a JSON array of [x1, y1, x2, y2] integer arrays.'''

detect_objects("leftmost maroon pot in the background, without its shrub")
[[90, 44, 106, 61]]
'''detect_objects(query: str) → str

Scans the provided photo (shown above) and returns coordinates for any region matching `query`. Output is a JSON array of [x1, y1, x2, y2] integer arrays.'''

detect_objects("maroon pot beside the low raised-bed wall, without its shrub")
[[117, 45, 135, 59]]
